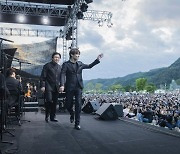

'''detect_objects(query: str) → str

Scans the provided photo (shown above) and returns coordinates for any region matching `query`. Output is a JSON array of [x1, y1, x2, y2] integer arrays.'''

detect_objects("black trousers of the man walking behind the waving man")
[[45, 91, 59, 119]]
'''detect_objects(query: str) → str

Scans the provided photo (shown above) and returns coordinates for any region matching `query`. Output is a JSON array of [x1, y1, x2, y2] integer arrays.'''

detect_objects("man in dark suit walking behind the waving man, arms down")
[[41, 52, 61, 122]]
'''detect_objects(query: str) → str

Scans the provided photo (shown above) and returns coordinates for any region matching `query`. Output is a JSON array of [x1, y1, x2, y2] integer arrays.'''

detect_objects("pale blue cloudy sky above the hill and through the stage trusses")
[[1, 0, 180, 80]]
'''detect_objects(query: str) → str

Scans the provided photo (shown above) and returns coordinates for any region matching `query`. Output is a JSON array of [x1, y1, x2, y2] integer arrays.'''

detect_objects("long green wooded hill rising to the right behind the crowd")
[[84, 58, 180, 89]]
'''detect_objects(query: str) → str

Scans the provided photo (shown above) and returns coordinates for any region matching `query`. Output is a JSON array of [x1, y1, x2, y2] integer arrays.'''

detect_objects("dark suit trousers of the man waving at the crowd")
[[66, 88, 82, 125]]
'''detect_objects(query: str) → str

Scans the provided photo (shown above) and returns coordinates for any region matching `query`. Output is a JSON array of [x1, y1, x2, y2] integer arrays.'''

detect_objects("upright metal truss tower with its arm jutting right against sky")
[[62, 0, 113, 61]]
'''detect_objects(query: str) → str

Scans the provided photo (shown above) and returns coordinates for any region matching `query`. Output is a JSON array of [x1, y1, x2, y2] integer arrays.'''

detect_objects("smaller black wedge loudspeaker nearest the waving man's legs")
[[82, 101, 100, 113]]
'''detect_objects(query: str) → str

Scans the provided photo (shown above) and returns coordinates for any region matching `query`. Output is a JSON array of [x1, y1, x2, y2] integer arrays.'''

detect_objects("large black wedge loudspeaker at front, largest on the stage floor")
[[96, 103, 118, 120]]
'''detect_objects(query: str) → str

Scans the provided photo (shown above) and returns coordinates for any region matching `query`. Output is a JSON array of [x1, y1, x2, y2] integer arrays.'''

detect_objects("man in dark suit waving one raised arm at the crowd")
[[60, 49, 103, 130]]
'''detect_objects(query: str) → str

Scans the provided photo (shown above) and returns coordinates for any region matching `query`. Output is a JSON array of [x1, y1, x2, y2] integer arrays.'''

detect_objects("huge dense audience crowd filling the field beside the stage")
[[83, 93, 180, 131]]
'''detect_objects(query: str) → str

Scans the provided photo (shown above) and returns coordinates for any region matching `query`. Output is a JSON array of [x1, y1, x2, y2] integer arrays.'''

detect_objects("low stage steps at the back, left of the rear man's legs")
[[23, 102, 39, 112]]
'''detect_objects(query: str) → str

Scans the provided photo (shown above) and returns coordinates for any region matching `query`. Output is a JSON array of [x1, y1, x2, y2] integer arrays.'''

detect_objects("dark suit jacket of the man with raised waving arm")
[[61, 59, 100, 91]]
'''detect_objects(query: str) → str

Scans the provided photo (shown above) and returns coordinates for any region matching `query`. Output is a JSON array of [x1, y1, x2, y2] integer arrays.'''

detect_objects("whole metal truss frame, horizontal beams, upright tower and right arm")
[[0, 0, 112, 61]]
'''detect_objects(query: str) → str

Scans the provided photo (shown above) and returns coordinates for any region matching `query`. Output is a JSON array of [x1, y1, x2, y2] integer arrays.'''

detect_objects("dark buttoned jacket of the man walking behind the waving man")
[[40, 61, 61, 91]]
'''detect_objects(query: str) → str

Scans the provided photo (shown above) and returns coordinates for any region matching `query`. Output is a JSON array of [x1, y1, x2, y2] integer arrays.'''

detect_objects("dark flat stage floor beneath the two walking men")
[[0, 112, 180, 154]]
